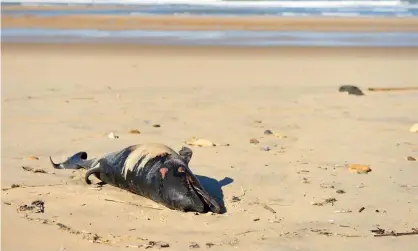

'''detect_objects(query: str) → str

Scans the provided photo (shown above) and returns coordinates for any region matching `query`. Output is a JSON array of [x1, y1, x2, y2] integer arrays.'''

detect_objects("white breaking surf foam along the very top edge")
[[1, 0, 405, 8]]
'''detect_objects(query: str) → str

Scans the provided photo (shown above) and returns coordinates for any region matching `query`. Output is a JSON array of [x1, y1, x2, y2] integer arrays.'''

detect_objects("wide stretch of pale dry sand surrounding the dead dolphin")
[[2, 44, 418, 251]]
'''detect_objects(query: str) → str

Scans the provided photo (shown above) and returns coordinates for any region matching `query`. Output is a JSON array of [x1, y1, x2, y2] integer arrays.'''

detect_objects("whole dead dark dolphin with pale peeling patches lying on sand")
[[50, 143, 223, 213]]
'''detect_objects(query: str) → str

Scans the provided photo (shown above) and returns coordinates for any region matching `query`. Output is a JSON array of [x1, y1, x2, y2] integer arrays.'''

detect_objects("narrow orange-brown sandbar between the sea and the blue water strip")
[[1, 15, 418, 32]]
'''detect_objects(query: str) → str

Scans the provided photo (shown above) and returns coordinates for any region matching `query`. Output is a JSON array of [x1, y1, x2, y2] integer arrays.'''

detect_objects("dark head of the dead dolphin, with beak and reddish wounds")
[[156, 159, 222, 213]]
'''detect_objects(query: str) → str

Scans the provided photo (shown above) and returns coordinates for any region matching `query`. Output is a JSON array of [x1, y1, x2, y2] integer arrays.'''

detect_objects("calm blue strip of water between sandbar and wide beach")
[[2, 28, 418, 47]]
